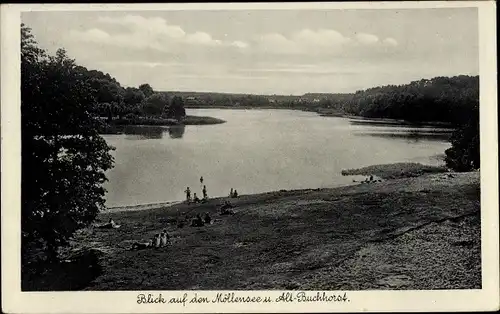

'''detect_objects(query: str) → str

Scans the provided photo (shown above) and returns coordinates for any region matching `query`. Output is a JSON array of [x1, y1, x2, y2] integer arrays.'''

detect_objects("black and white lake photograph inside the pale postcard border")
[[2, 1, 498, 312]]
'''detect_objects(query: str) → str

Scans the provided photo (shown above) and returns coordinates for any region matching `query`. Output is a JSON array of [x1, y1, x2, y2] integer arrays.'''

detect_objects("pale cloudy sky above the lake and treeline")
[[21, 8, 479, 95]]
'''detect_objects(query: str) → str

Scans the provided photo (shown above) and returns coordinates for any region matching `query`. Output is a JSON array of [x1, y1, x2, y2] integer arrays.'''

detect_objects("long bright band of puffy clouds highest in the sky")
[[69, 14, 398, 55]]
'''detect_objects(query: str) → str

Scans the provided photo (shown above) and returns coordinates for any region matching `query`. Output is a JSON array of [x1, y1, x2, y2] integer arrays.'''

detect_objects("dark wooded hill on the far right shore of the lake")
[[343, 75, 479, 125]]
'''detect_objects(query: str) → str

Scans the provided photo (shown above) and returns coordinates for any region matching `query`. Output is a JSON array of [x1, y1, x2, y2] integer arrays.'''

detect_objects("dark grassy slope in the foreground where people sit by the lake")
[[68, 173, 481, 290]]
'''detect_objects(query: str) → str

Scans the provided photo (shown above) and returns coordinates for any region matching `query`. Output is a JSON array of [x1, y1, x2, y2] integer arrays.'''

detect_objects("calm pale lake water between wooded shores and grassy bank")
[[104, 109, 450, 207]]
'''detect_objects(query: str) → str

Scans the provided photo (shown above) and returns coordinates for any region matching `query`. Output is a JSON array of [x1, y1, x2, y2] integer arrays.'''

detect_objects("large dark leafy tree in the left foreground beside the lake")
[[21, 24, 113, 261]]
